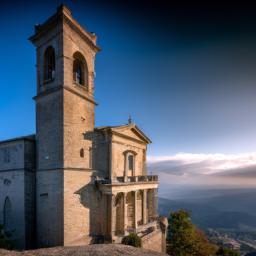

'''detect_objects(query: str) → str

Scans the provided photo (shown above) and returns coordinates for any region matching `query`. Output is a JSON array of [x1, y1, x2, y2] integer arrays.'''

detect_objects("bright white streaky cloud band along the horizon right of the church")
[[147, 152, 256, 177]]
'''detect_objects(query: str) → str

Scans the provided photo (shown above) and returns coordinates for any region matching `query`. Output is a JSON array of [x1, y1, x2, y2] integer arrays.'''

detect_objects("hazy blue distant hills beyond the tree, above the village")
[[158, 189, 256, 231]]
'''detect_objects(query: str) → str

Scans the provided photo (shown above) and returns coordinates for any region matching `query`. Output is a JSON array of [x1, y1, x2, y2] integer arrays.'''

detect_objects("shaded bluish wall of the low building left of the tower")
[[0, 138, 35, 248]]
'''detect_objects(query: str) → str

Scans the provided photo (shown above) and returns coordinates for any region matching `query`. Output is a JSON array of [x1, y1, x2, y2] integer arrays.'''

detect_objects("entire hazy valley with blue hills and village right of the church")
[[158, 188, 256, 255]]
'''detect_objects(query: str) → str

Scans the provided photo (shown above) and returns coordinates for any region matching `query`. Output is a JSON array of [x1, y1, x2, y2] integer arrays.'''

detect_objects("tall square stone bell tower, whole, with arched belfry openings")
[[30, 6, 99, 246]]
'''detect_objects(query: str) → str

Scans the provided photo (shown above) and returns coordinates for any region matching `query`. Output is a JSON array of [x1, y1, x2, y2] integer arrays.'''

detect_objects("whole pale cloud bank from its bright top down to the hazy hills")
[[148, 152, 256, 194]]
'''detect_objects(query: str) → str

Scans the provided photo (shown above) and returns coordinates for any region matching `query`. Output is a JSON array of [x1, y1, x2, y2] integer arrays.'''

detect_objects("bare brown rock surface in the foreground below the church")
[[0, 244, 167, 256]]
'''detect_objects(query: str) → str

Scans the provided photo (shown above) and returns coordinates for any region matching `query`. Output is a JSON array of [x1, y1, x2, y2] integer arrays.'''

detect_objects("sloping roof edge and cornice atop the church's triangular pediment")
[[95, 123, 152, 144]]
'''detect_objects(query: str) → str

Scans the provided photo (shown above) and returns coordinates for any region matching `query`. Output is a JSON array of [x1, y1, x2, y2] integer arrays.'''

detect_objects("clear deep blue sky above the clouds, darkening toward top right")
[[0, 0, 256, 160]]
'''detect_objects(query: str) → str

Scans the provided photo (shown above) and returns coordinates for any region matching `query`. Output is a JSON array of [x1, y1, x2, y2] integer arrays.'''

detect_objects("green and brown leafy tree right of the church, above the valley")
[[167, 210, 217, 256]]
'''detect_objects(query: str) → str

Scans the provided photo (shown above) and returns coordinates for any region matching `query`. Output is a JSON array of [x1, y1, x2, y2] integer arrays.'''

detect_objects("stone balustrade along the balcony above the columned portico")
[[97, 175, 158, 184]]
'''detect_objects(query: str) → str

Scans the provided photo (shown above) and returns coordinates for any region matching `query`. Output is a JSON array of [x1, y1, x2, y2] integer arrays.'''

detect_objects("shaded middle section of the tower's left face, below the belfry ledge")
[[36, 91, 63, 170]]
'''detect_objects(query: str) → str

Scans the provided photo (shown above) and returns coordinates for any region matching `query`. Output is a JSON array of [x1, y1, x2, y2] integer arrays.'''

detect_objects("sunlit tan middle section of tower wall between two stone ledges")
[[63, 91, 94, 169]]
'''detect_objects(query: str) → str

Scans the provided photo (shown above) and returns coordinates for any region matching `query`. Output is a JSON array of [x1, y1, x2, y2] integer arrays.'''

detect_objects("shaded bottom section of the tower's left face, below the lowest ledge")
[[36, 170, 64, 247]]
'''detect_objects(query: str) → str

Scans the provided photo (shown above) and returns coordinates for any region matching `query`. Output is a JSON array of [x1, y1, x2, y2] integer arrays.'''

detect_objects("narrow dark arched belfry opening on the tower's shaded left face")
[[44, 46, 55, 81]]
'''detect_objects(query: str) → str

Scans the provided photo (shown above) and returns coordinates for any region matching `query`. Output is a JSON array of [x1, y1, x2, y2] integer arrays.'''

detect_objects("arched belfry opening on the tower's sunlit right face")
[[73, 52, 88, 88]]
